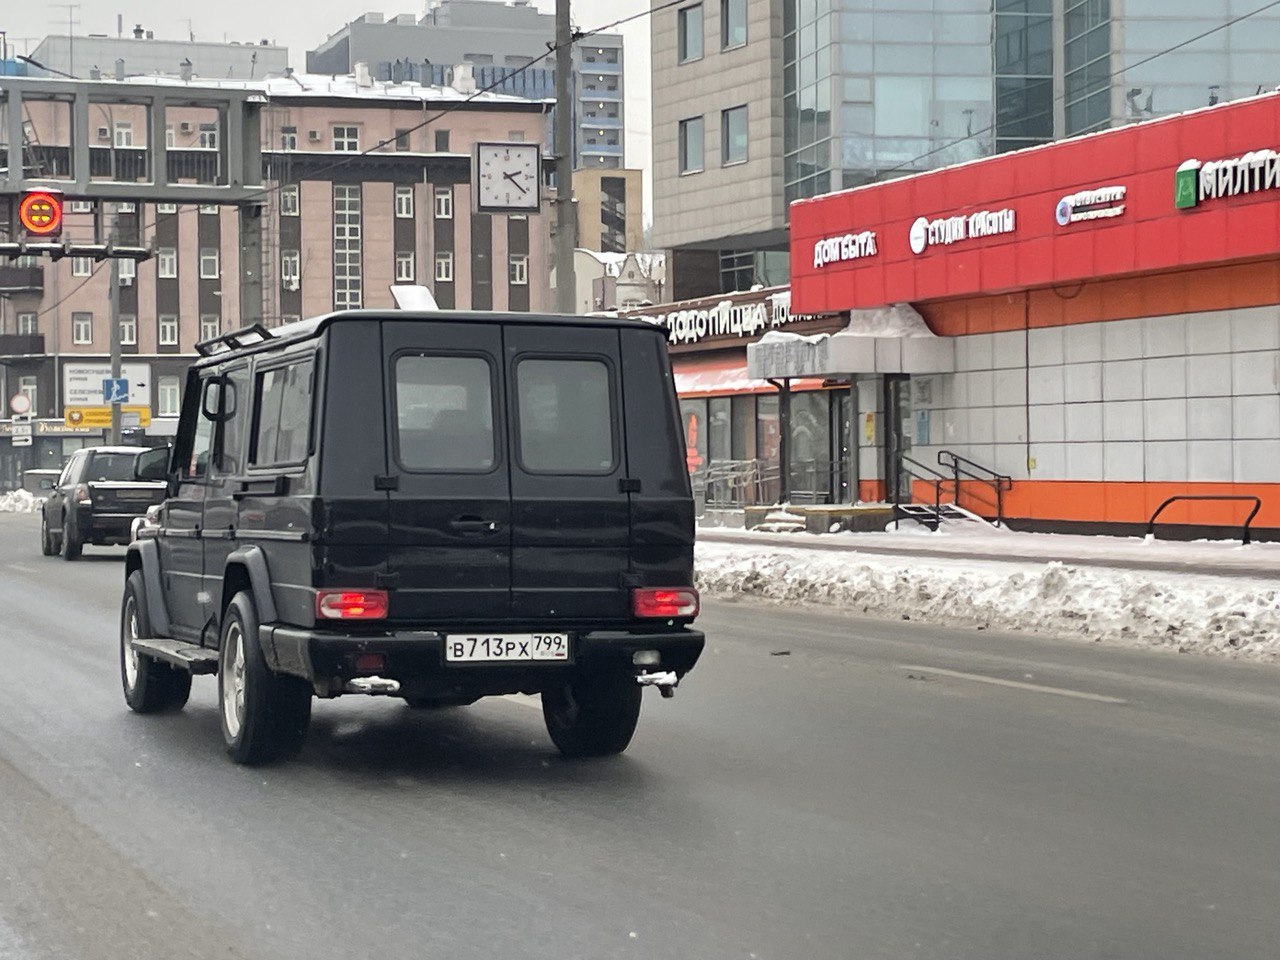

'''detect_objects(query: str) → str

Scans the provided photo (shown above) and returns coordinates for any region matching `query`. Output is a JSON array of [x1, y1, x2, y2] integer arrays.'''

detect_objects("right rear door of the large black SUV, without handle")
[[504, 323, 631, 623]]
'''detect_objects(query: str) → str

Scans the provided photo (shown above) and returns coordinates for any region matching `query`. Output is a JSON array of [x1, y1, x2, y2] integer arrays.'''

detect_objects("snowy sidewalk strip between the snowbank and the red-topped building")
[[698, 524, 1280, 580]]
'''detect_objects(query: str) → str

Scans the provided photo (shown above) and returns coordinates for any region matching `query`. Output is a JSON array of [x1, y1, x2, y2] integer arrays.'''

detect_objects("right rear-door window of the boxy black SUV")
[[516, 360, 613, 474]]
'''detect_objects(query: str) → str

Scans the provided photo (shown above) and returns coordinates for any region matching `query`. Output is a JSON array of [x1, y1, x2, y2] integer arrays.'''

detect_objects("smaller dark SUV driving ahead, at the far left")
[[40, 447, 168, 559]]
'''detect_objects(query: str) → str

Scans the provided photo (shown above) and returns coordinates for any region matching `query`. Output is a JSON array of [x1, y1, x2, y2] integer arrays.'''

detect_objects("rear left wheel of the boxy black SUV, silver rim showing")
[[218, 591, 311, 765]]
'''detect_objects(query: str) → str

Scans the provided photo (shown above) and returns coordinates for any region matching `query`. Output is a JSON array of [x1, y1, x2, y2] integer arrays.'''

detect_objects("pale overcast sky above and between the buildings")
[[0, 0, 652, 209]]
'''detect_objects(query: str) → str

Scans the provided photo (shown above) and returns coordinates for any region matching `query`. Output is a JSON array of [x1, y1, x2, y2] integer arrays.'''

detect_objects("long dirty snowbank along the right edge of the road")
[[696, 543, 1280, 659]]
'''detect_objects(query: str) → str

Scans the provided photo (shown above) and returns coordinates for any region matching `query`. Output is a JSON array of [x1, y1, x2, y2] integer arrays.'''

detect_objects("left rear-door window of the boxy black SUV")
[[396, 356, 497, 472]]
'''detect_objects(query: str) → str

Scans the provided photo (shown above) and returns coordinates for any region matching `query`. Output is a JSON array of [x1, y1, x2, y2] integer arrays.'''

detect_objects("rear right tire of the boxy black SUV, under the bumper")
[[543, 673, 641, 756]]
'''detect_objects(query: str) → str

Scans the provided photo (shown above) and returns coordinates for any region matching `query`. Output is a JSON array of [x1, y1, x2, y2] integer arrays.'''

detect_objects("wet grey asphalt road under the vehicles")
[[0, 516, 1280, 960]]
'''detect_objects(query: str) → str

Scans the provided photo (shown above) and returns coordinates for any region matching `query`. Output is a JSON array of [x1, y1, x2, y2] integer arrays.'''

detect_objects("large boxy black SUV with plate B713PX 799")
[[120, 311, 703, 763]]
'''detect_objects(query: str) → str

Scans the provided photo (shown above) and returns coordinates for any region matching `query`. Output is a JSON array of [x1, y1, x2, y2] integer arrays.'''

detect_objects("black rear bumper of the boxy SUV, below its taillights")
[[259, 623, 705, 696]]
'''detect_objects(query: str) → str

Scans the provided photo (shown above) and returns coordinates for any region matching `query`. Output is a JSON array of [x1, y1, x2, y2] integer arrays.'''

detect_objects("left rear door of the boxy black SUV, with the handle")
[[383, 320, 512, 622]]
